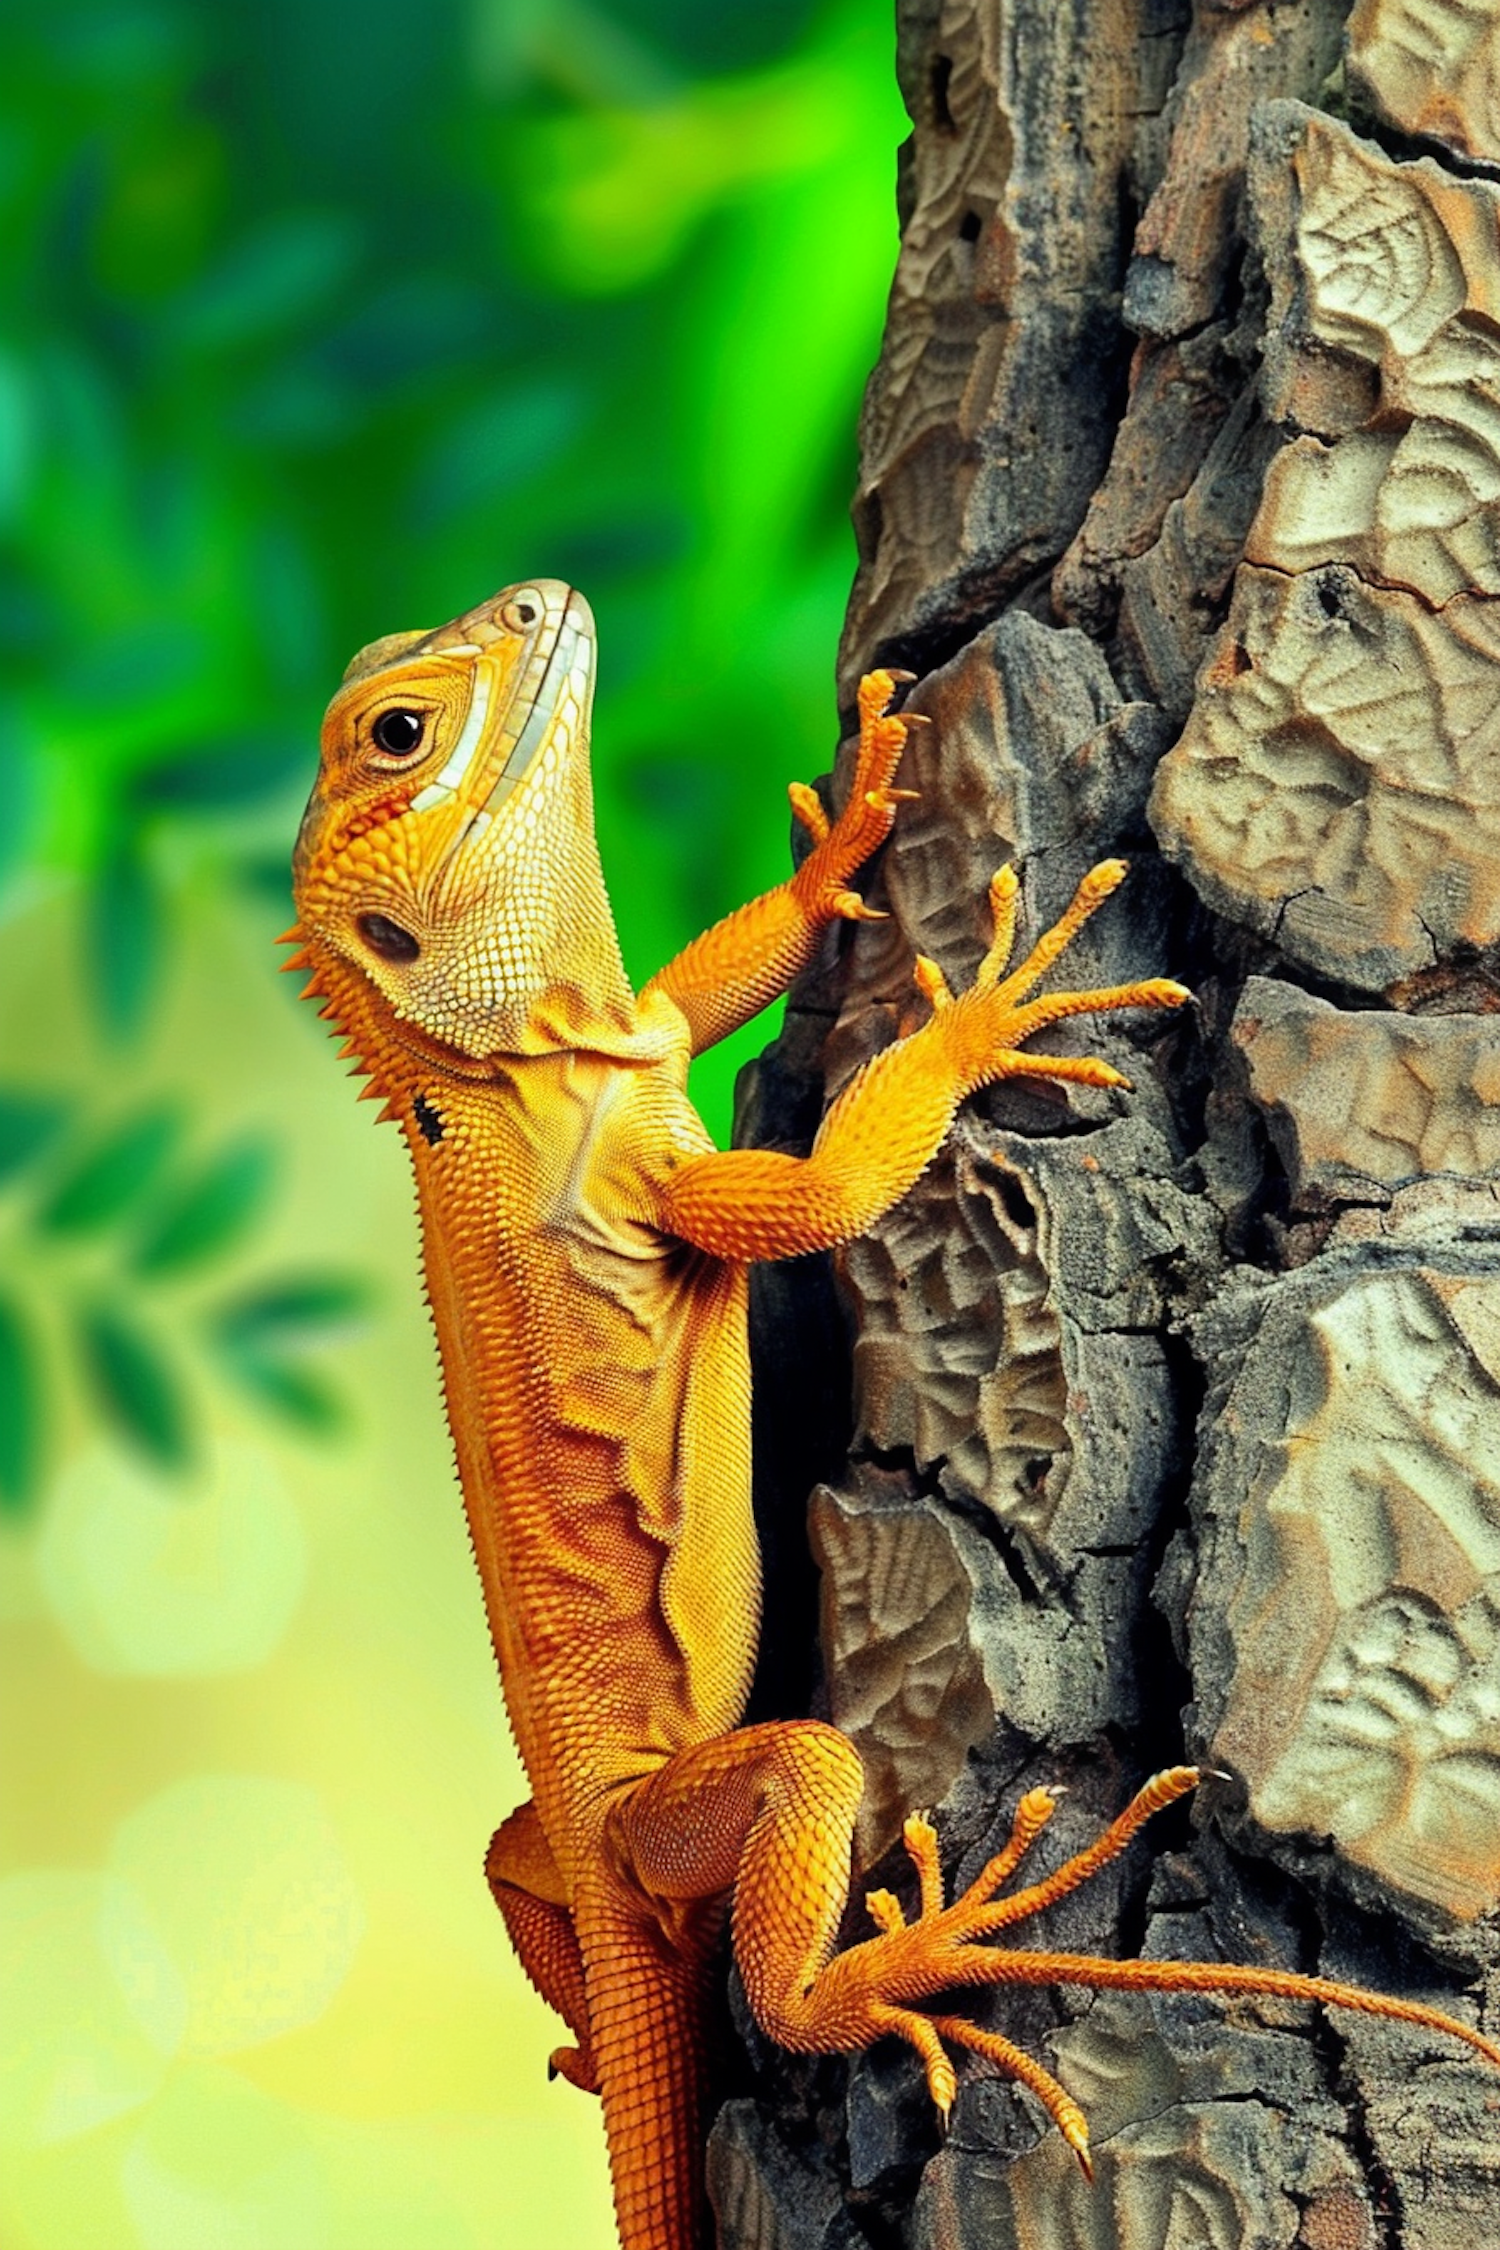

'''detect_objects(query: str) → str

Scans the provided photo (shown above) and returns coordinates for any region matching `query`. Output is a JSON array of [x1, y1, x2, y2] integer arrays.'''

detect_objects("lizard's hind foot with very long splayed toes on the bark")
[[845, 1766, 1500, 2178]]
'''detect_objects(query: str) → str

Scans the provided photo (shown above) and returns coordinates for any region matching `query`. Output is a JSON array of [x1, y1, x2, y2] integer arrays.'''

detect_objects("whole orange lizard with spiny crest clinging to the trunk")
[[288, 578, 1500, 2250]]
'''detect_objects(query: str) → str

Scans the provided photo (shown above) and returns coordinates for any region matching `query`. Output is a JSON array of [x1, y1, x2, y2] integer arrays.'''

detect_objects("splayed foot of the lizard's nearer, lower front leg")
[[913, 860, 1192, 1089]]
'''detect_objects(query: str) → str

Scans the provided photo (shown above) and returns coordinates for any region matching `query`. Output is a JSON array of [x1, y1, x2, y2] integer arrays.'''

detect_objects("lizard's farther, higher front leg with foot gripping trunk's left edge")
[[643, 673, 927, 1055]]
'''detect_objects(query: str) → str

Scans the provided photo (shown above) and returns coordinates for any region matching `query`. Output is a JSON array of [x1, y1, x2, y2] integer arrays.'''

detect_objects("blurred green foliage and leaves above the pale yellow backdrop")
[[0, 0, 900, 1501]]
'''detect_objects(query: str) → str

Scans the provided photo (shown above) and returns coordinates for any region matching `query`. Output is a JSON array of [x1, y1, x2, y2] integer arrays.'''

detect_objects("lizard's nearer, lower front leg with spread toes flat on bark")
[[661, 860, 1187, 1258]]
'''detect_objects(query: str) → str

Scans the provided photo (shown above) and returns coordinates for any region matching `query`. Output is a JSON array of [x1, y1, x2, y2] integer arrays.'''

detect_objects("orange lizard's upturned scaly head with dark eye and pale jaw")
[[292, 578, 623, 1062]]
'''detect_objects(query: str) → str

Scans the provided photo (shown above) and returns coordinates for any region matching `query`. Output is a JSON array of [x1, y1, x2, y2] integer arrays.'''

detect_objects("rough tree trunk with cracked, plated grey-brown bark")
[[711, 0, 1500, 2250]]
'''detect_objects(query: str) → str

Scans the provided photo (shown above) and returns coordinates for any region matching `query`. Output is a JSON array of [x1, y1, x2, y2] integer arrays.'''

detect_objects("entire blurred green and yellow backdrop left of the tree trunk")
[[0, 0, 904, 2250]]
